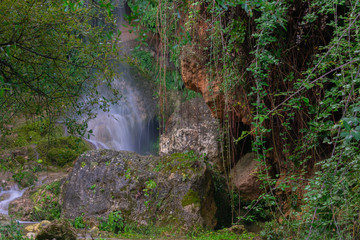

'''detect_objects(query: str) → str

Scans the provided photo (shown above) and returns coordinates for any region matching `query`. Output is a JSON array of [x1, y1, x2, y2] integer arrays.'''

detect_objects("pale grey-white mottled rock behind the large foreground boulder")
[[159, 98, 221, 166]]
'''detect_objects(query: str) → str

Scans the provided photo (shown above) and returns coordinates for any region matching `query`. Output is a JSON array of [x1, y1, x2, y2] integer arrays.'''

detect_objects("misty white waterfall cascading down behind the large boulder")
[[88, 3, 158, 154]]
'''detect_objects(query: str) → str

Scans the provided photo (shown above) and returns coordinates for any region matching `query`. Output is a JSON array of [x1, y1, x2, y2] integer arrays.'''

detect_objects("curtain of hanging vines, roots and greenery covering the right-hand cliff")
[[129, 0, 360, 239]]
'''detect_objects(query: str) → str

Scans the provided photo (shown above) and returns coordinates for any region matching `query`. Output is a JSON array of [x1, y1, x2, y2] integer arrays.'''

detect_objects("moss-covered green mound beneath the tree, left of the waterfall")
[[0, 121, 90, 172]]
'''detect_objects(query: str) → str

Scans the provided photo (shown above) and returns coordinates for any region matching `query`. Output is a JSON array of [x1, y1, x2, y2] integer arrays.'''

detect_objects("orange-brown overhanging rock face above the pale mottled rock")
[[180, 36, 251, 125]]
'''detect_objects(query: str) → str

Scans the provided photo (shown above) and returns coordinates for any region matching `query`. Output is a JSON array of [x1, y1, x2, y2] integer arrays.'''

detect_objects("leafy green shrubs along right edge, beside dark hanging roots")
[[256, 1, 360, 239]]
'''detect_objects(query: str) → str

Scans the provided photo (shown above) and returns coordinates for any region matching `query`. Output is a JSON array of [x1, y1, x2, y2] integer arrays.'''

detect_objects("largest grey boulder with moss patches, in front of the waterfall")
[[62, 150, 216, 229]]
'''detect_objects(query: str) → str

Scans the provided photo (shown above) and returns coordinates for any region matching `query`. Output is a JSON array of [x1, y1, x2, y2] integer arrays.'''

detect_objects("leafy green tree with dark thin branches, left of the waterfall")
[[0, 0, 117, 138]]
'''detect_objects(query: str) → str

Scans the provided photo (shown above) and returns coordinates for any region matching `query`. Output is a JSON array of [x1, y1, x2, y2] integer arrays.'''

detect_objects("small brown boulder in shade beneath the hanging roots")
[[230, 153, 261, 201]]
